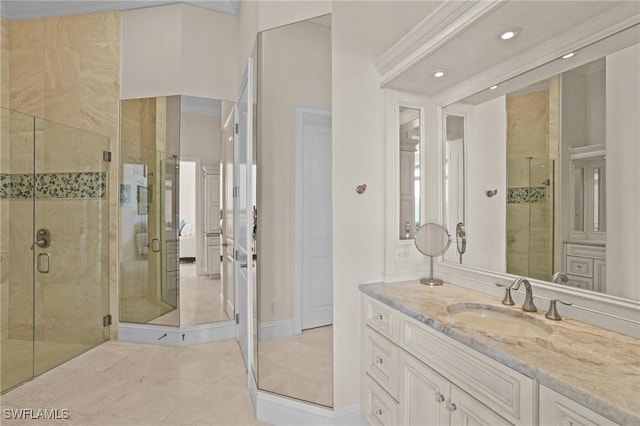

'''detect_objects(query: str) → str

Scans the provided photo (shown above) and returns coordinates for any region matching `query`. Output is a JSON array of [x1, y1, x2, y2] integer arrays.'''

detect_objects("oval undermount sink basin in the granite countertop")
[[447, 303, 553, 337]]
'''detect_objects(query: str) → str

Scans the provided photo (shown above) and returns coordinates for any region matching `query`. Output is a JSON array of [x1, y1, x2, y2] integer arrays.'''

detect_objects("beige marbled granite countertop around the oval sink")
[[360, 281, 640, 425]]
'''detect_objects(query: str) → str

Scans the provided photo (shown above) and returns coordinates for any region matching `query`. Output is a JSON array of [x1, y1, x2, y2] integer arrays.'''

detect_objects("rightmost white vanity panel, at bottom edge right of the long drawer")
[[538, 385, 617, 426]]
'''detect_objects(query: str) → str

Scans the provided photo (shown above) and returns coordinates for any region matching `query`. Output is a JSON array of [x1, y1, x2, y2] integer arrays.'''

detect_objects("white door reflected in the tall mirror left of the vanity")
[[296, 107, 333, 331]]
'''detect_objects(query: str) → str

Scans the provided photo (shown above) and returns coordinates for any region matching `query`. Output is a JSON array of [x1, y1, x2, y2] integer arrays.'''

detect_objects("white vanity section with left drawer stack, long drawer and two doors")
[[362, 296, 535, 426]]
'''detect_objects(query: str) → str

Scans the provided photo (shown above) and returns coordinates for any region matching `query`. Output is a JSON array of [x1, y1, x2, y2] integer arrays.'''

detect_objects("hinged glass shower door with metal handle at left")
[[30, 118, 109, 375]]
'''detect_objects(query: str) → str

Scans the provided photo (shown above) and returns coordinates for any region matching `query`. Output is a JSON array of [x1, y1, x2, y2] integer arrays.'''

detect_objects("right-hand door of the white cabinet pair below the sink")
[[447, 386, 512, 426]]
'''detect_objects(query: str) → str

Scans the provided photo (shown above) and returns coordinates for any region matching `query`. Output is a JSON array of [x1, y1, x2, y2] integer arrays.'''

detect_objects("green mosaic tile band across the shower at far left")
[[0, 172, 107, 200]]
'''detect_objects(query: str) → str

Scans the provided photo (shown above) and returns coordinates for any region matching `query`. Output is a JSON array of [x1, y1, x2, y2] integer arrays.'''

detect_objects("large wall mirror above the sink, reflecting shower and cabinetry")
[[442, 25, 640, 301]]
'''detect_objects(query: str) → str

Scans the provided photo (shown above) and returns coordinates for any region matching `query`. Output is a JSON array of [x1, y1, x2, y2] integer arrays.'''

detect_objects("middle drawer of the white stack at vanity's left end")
[[364, 327, 400, 400]]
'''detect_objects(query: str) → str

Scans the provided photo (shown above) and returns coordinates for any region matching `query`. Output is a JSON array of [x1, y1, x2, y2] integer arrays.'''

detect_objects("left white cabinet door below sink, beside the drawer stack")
[[399, 352, 450, 426]]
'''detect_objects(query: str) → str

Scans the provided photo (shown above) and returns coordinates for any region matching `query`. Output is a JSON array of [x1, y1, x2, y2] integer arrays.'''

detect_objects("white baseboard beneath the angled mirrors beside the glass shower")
[[118, 321, 237, 346]]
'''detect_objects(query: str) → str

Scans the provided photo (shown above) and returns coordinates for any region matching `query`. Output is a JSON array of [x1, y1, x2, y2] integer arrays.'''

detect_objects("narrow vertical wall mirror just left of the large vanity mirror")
[[398, 106, 421, 240]]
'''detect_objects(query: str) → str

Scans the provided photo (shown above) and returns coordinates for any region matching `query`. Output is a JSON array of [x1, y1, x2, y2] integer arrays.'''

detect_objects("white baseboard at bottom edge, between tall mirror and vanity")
[[252, 390, 368, 426]]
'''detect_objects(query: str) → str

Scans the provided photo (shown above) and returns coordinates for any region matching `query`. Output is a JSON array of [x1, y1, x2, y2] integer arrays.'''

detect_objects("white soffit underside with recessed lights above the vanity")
[[385, 1, 640, 95]]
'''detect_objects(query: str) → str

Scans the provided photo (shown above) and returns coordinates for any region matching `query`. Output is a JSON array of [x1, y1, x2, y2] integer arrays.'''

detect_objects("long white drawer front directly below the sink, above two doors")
[[400, 315, 534, 425]]
